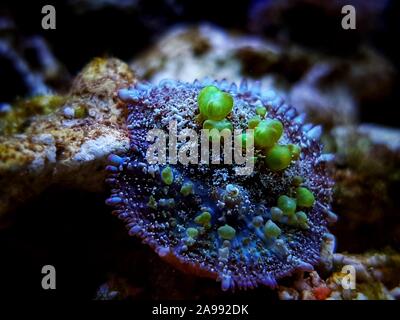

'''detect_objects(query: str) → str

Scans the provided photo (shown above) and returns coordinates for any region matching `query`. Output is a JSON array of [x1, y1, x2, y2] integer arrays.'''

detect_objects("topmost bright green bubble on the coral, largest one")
[[197, 86, 233, 120]]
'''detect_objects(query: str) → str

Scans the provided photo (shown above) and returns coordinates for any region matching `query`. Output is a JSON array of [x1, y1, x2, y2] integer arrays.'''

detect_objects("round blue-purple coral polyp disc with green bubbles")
[[107, 80, 334, 290]]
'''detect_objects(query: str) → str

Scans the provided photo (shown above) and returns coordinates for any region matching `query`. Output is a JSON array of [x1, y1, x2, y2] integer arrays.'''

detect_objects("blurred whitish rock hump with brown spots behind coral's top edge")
[[131, 24, 281, 83]]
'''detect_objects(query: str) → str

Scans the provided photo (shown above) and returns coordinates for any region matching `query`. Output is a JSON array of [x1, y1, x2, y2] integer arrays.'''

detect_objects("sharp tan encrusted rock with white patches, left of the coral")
[[0, 58, 136, 222]]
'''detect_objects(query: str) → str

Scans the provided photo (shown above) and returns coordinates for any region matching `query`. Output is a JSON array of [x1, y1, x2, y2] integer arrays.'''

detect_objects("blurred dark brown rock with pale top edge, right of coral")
[[331, 124, 400, 252]]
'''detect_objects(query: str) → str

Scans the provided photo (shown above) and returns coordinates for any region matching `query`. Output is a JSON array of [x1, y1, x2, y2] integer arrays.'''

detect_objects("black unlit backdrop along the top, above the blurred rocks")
[[0, 0, 400, 126]]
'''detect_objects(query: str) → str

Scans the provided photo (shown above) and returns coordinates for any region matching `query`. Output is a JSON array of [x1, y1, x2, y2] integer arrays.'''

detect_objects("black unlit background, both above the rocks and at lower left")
[[0, 0, 400, 299]]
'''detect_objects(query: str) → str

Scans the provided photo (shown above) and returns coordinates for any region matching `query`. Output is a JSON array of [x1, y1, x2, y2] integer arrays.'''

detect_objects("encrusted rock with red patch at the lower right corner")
[[278, 251, 400, 300]]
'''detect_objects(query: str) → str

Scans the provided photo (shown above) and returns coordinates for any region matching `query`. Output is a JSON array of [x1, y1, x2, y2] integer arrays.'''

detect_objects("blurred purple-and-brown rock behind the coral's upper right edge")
[[288, 47, 395, 129]]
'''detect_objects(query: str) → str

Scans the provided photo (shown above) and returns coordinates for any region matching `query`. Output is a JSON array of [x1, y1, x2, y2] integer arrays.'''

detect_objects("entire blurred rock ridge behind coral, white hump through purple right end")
[[131, 24, 394, 129]]
